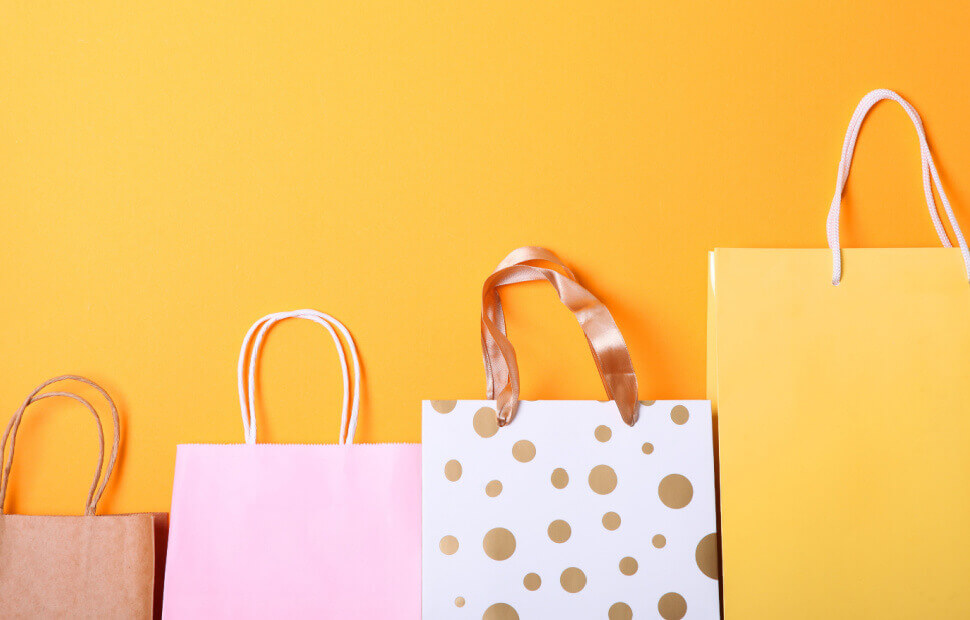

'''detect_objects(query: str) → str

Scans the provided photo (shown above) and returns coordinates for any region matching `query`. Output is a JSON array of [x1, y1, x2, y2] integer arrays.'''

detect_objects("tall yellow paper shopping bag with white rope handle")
[[708, 90, 970, 619]]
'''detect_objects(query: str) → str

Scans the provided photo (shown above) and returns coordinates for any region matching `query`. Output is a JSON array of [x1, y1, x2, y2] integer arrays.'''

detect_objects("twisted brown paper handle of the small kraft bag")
[[0, 375, 121, 516]]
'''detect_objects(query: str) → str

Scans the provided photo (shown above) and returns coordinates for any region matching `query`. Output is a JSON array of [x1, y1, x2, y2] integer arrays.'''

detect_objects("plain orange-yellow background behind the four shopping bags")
[[0, 0, 970, 513]]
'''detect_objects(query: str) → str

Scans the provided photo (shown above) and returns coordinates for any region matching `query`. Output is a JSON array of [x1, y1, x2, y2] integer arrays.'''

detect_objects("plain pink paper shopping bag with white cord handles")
[[163, 310, 421, 619]]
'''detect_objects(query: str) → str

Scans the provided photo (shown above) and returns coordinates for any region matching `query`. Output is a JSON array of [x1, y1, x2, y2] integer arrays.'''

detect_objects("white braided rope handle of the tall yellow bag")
[[825, 88, 970, 286]]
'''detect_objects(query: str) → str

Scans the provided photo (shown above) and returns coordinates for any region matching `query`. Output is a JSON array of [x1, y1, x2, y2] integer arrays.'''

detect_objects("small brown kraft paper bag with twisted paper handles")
[[0, 375, 155, 619]]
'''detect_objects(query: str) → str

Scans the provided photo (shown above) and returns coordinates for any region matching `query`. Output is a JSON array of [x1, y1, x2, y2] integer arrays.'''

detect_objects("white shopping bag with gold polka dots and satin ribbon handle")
[[422, 248, 719, 620]]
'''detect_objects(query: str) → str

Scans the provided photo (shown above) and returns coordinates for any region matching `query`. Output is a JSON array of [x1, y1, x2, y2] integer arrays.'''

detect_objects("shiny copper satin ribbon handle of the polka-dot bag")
[[481, 248, 639, 426]]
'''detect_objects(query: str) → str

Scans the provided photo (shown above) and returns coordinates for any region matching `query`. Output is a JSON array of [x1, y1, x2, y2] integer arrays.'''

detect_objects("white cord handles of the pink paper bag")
[[238, 310, 360, 444]]
